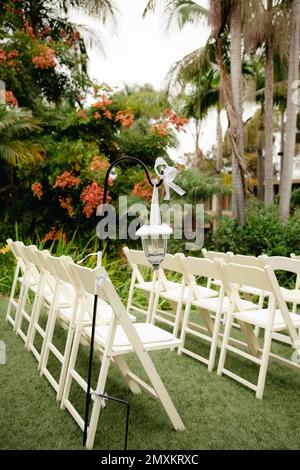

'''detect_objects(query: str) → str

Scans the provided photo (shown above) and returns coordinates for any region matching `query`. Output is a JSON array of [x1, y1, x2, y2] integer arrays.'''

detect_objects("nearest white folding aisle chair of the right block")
[[218, 262, 300, 399]]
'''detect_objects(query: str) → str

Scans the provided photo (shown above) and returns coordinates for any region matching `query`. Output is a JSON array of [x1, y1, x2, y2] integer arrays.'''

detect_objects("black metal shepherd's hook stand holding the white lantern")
[[83, 156, 163, 450]]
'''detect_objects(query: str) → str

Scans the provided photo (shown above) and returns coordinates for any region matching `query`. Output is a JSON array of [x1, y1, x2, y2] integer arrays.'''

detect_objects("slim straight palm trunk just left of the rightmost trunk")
[[264, 0, 274, 206]]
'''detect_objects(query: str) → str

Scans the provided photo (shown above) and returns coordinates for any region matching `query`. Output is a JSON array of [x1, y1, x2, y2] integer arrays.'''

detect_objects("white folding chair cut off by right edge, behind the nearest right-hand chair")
[[259, 255, 300, 344]]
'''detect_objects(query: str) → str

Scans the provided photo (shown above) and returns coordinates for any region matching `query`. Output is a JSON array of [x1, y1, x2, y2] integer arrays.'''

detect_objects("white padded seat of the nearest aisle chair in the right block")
[[234, 308, 300, 331]]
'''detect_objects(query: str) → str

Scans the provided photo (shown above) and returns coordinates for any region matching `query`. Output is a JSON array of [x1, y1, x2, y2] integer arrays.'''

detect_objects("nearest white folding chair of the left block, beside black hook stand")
[[61, 265, 184, 448]]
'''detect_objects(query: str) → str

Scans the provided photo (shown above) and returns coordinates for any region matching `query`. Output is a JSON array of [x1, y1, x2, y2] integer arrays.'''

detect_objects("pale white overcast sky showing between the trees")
[[72, 0, 253, 157]]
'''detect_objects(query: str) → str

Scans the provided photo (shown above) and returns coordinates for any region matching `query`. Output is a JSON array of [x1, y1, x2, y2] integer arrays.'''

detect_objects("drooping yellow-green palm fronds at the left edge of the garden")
[[0, 105, 43, 192]]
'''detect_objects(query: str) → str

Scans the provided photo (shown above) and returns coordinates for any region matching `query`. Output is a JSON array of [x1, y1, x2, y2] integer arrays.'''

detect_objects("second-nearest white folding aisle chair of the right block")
[[178, 257, 256, 372]]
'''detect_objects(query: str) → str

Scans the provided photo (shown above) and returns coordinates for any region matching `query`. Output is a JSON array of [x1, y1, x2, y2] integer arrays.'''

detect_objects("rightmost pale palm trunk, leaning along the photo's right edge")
[[279, 0, 300, 223]]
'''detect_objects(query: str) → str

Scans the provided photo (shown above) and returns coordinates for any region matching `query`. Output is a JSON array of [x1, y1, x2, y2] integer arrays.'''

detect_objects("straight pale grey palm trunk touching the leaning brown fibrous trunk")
[[230, 2, 246, 225]]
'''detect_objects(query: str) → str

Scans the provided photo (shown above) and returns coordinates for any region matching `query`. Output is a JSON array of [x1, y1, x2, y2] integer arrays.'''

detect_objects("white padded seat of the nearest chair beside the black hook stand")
[[84, 323, 181, 352]]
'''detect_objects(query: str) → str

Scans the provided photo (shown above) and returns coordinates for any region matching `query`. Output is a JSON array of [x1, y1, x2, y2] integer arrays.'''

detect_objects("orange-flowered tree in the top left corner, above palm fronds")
[[0, 0, 95, 109]]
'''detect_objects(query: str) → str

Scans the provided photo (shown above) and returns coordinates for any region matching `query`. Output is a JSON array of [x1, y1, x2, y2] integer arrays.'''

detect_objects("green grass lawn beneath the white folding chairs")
[[0, 298, 300, 449]]
